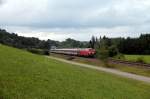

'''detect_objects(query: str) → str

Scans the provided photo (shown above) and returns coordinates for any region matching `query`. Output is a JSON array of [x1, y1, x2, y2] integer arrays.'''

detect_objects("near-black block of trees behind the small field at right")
[[118, 34, 150, 55]]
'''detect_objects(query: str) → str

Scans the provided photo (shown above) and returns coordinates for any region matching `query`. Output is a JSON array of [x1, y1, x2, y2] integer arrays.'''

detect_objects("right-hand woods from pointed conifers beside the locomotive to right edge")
[[90, 34, 150, 57]]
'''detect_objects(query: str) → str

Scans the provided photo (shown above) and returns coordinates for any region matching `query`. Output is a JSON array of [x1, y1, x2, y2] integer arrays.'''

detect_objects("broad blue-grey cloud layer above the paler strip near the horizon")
[[0, 0, 150, 28]]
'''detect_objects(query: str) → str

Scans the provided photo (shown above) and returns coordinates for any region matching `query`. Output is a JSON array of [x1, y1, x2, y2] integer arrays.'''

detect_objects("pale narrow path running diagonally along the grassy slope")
[[46, 56, 150, 83]]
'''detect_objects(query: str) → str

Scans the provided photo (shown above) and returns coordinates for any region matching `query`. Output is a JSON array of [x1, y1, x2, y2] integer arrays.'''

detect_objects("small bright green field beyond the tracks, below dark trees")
[[125, 55, 150, 63]]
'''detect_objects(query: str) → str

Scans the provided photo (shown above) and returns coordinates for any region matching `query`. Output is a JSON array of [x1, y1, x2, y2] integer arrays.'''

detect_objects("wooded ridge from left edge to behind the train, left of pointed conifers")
[[0, 29, 89, 49]]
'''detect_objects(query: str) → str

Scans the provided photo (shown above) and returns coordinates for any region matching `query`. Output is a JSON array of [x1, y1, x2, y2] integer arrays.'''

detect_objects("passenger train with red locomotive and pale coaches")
[[50, 48, 96, 57]]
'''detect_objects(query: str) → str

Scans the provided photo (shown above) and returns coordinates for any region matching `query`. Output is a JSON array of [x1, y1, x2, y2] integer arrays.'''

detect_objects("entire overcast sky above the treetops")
[[0, 0, 150, 41]]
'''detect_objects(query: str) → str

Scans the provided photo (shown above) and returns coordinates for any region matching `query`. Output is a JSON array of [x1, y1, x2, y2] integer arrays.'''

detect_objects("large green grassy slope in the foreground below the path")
[[0, 45, 150, 99]]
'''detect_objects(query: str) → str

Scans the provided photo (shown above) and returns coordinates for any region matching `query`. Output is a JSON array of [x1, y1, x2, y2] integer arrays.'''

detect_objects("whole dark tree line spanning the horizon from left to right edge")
[[0, 29, 150, 56]]
